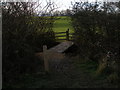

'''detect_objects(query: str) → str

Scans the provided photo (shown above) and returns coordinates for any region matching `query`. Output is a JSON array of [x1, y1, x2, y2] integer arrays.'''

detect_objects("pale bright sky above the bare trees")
[[0, 0, 120, 11]]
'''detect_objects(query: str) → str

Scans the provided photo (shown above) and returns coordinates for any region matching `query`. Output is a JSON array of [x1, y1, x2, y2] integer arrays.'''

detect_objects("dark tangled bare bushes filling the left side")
[[2, 2, 55, 88]]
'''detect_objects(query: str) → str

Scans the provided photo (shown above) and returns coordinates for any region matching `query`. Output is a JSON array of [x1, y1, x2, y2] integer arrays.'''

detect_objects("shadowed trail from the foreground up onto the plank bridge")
[[12, 43, 117, 88]]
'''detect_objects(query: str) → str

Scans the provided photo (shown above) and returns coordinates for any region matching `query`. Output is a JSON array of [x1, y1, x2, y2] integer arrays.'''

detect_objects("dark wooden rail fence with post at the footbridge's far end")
[[55, 29, 74, 41]]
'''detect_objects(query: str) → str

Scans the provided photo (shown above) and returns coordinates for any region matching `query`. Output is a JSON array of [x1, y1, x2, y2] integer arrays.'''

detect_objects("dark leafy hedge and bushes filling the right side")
[[71, 2, 120, 82]]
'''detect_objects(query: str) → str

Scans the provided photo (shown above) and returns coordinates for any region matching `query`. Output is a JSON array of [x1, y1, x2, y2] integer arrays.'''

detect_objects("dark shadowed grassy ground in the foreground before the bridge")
[[9, 54, 117, 88]]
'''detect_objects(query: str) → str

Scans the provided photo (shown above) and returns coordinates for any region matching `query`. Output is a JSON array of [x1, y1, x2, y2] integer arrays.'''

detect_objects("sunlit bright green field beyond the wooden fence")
[[53, 16, 73, 39]]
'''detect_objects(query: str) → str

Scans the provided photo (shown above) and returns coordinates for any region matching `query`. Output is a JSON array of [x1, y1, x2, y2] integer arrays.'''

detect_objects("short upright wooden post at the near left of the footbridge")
[[43, 45, 49, 73]]
